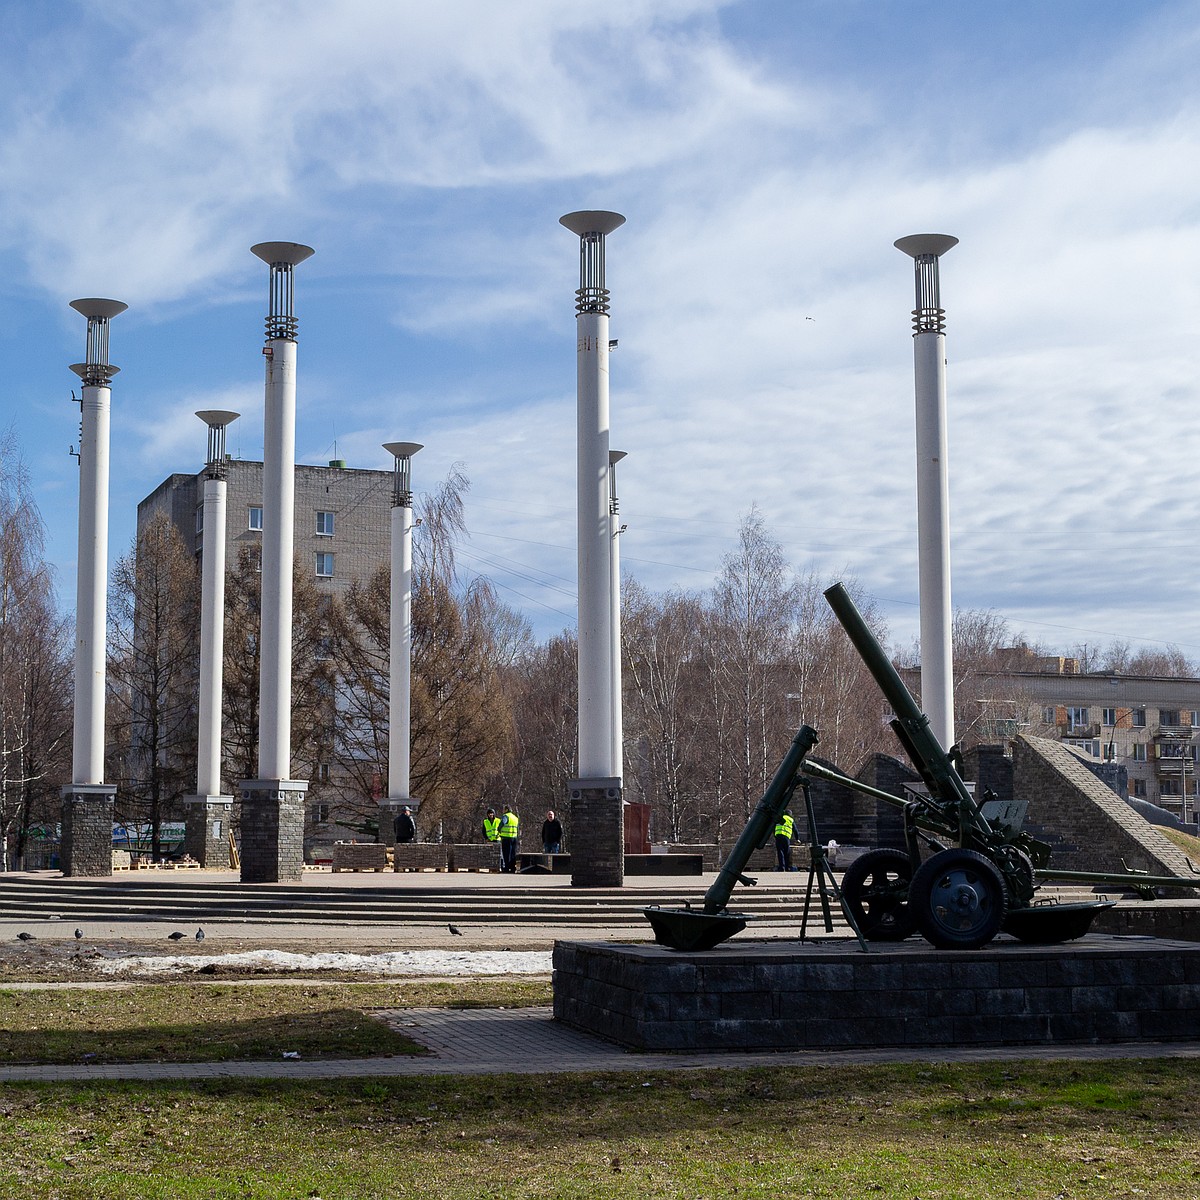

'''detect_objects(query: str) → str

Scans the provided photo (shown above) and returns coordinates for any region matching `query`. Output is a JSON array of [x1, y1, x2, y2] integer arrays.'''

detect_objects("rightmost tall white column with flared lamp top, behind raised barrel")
[[895, 234, 958, 750]]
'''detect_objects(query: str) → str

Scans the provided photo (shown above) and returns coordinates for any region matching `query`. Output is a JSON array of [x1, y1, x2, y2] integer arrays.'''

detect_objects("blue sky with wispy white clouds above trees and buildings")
[[0, 0, 1200, 659]]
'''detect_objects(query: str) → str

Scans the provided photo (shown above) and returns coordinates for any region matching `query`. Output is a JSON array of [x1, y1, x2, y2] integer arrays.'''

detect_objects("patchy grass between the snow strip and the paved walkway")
[[0, 979, 551, 1063]]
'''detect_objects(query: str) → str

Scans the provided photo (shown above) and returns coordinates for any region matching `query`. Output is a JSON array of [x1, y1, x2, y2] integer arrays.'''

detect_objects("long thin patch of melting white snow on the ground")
[[89, 950, 551, 976]]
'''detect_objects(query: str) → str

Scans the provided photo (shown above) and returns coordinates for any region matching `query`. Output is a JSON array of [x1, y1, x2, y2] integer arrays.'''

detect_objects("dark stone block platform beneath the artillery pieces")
[[554, 934, 1200, 1051]]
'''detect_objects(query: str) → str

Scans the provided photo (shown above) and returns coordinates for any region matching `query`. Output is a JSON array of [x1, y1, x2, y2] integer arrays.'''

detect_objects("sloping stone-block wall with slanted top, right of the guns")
[[1013, 734, 1194, 895]]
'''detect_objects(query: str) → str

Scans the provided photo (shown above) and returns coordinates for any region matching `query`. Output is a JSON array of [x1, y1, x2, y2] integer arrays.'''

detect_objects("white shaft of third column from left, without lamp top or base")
[[258, 337, 296, 779]]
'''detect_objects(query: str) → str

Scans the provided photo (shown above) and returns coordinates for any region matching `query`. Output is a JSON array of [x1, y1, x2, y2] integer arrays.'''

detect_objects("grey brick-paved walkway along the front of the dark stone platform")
[[0, 1008, 1200, 1082]]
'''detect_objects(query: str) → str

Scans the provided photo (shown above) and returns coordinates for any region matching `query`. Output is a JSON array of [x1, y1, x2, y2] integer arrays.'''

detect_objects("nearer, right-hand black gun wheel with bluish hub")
[[908, 850, 1008, 950]]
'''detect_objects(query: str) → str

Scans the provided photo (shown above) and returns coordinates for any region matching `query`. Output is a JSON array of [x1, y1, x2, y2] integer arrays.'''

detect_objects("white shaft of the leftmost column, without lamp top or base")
[[71, 384, 112, 784]]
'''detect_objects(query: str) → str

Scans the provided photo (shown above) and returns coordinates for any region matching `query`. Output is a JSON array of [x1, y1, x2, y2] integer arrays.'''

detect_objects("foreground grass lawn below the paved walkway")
[[0, 1060, 1200, 1200]]
